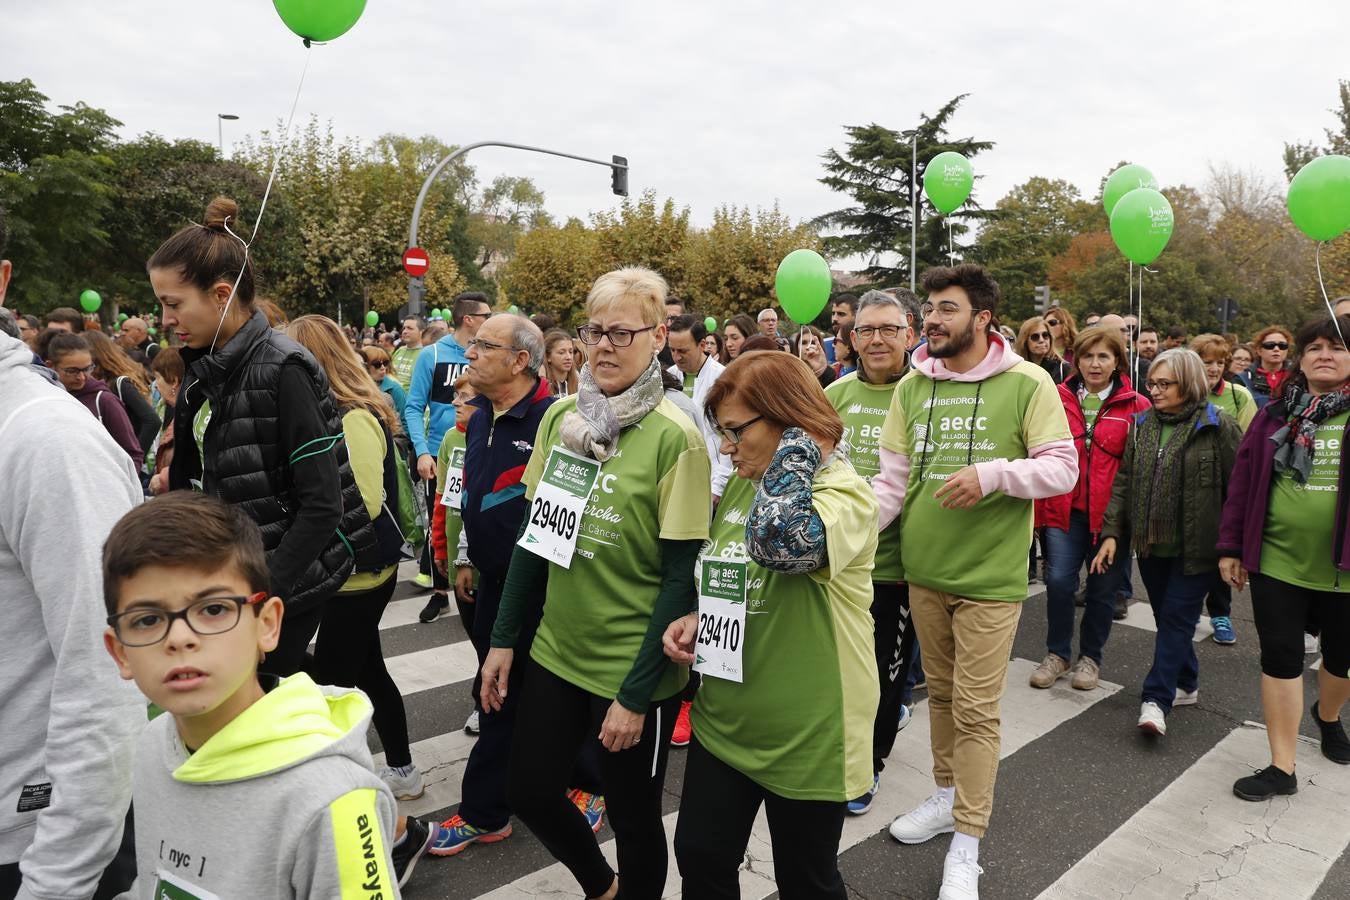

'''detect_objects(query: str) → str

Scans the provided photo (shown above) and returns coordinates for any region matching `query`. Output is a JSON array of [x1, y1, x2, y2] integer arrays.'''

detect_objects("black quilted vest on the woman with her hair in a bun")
[[169, 312, 375, 613]]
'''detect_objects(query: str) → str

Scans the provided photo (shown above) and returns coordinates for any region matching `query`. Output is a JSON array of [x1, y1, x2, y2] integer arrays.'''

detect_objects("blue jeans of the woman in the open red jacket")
[[1045, 510, 1130, 665]]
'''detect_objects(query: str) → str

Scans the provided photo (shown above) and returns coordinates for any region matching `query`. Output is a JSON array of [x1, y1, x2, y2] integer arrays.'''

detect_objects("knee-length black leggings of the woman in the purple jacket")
[[1251, 572, 1350, 679]]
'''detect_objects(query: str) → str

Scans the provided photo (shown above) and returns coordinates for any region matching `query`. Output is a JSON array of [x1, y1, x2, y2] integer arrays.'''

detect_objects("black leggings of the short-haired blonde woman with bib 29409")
[[509, 653, 679, 900]]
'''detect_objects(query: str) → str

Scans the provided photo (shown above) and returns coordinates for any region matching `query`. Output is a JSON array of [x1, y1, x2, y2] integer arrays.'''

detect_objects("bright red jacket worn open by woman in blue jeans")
[[1035, 375, 1153, 536]]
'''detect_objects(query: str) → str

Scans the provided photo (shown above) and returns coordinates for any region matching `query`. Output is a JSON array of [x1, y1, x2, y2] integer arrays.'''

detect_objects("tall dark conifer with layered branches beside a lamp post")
[[815, 94, 994, 283]]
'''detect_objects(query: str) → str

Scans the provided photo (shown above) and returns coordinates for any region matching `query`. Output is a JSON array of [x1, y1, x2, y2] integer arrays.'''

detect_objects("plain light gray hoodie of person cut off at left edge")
[[0, 335, 146, 900]]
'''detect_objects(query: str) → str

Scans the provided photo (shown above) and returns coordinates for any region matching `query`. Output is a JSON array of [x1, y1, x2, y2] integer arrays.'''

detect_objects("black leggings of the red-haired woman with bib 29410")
[[675, 739, 842, 900]]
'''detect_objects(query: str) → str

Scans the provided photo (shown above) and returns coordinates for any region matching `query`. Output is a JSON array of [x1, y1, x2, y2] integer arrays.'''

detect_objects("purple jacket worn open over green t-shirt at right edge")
[[1219, 401, 1350, 572]]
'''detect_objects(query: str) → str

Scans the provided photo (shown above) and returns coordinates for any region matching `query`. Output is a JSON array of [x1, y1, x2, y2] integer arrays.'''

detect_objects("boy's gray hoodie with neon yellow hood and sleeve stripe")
[[120, 673, 400, 900]]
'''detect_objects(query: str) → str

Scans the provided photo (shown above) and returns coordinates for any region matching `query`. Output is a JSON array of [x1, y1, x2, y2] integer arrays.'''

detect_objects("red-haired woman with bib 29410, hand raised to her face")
[[661, 352, 874, 900]]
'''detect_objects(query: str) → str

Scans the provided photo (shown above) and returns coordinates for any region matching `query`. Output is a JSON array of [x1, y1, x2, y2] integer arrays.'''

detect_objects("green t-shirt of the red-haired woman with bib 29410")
[[693, 459, 880, 801]]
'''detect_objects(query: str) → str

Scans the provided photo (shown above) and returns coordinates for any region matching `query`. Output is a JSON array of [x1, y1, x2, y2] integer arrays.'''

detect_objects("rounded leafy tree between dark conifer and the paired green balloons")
[[971, 177, 1106, 321]]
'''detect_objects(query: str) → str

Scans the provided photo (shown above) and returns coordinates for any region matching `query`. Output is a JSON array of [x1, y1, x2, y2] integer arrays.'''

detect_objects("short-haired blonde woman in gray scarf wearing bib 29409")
[[481, 267, 713, 900]]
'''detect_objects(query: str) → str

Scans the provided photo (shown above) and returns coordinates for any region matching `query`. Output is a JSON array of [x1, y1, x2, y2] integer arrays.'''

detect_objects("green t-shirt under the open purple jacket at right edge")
[[1261, 413, 1350, 591]]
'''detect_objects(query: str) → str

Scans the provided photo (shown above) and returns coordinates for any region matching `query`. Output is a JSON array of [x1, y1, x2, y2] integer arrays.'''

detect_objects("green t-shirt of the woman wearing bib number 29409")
[[522, 397, 713, 700]]
